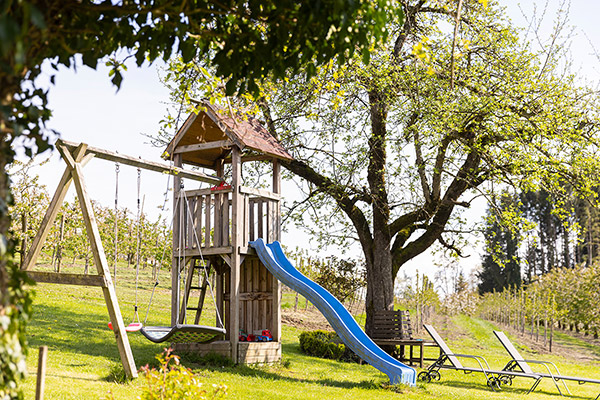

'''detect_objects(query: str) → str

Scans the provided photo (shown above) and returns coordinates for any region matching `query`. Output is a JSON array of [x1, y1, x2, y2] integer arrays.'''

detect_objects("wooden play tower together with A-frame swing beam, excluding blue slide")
[[22, 104, 291, 377]]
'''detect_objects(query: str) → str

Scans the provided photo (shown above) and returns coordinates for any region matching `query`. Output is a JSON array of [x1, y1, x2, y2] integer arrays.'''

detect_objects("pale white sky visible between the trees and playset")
[[14, 0, 600, 292]]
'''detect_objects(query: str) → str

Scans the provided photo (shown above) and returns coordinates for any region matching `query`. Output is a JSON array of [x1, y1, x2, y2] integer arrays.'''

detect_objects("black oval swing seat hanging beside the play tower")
[[140, 324, 225, 343]]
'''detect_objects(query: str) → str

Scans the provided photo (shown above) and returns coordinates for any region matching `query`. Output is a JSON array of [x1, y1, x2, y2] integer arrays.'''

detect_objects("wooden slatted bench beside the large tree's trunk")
[[371, 310, 437, 368]]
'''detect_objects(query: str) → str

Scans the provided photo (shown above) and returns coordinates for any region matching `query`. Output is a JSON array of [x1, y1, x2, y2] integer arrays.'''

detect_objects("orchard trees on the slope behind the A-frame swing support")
[[9, 163, 172, 272]]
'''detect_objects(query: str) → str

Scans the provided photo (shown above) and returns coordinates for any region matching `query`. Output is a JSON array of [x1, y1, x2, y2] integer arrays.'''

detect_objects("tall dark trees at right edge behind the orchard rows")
[[479, 184, 600, 293]]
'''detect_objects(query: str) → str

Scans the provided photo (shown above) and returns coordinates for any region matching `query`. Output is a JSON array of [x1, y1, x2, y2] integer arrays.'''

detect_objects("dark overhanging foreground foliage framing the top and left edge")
[[0, 0, 401, 398]]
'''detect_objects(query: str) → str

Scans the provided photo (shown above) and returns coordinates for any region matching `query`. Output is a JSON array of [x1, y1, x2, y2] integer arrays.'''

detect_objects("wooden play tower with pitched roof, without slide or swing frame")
[[163, 103, 292, 363]]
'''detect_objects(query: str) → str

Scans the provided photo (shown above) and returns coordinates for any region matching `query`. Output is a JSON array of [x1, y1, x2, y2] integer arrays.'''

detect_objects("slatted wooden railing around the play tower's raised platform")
[[173, 187, 281, 253]]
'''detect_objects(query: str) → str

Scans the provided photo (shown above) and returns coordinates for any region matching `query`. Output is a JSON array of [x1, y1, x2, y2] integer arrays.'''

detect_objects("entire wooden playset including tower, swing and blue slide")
[[22, 103, 416, 385]]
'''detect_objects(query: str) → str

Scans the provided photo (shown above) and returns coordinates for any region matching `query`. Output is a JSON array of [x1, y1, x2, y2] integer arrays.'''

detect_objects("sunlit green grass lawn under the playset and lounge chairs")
[[17, 260, 600, 400]]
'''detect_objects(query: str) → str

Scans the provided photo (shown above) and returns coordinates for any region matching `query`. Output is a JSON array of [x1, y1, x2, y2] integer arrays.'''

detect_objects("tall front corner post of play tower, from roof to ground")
[[230, 146, 241, 363]]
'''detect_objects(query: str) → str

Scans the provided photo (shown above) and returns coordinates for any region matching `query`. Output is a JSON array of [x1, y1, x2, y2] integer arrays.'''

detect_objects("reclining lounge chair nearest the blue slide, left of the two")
[[417, 325, 543, 393]]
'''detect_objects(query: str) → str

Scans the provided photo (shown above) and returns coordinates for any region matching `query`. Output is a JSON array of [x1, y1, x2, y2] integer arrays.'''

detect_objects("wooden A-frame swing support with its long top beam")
[[22, 140, 221, 378]]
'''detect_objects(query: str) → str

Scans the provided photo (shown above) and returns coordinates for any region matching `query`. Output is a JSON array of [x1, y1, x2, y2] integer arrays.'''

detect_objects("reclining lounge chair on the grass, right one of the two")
[[494, 331, 600, 400]]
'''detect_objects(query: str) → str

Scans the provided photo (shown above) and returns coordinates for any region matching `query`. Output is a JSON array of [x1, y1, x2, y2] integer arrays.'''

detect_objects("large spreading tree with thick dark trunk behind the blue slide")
[[166, 0, 598, 333]]
